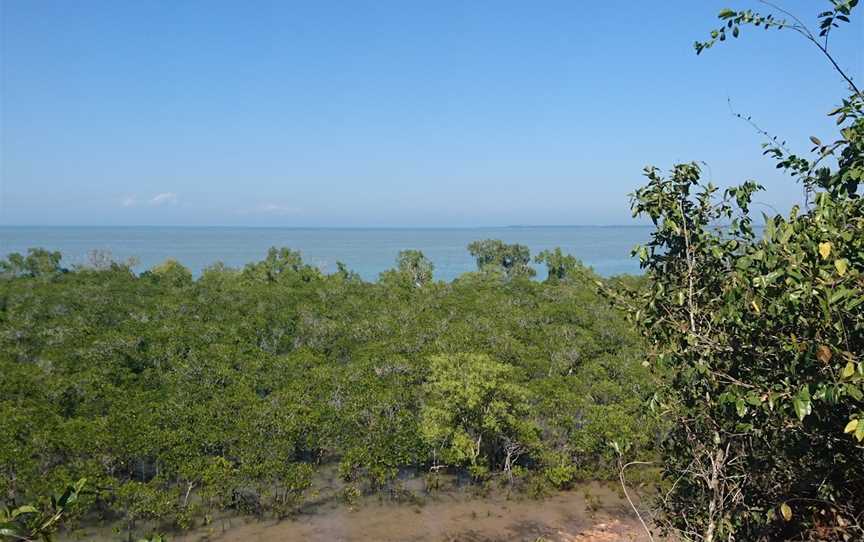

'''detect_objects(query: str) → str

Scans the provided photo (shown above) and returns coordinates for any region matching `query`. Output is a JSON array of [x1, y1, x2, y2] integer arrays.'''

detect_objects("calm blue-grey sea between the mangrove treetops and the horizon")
[[0, 226, 650, 280]]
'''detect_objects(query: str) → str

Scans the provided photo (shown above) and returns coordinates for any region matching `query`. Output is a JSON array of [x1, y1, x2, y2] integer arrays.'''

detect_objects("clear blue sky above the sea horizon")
[[0, 0, 864, 227]]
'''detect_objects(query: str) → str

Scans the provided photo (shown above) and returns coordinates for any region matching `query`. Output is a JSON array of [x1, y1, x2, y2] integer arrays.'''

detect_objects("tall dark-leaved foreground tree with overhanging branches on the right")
[[630, 1, 864, 542]]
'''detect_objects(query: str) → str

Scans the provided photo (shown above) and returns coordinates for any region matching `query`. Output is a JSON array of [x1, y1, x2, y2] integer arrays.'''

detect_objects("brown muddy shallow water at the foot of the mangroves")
[[172, 484, 647, 542]]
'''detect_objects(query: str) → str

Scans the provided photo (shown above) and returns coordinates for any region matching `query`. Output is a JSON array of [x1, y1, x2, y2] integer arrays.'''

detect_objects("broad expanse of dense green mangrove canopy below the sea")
[[0, 243, 654, 538]]
